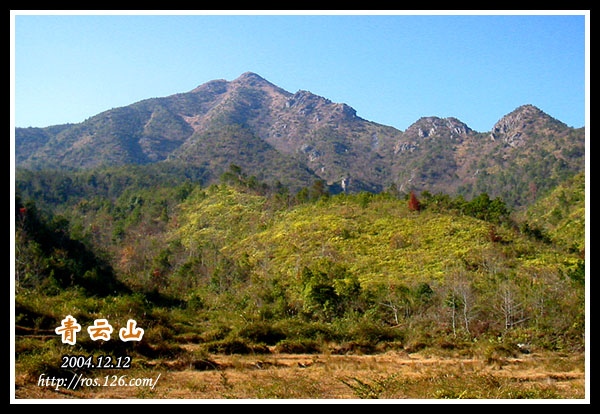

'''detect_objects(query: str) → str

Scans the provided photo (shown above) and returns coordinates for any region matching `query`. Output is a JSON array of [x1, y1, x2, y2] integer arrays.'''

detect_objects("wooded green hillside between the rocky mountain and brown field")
[[16, 166, 584, 368]]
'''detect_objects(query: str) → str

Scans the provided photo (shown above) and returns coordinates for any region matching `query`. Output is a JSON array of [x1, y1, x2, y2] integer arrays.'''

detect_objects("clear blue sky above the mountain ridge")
[[14, 12, 586, 131]]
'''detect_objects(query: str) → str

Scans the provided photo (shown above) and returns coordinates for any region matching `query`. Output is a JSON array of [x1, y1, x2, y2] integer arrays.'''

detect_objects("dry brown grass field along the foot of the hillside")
[[15, 351, 585, 400]]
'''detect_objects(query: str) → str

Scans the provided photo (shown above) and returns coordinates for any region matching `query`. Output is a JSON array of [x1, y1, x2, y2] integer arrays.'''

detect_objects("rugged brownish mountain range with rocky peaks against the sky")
[[15, 72, 584, 206]]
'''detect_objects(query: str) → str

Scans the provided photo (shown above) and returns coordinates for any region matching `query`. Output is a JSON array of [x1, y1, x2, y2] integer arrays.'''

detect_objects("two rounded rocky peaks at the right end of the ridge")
[[392, 105, 585, 206]]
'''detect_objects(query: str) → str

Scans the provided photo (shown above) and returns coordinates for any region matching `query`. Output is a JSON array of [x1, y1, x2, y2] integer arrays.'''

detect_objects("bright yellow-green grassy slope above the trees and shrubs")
[[173, 187, 573, 290]]
